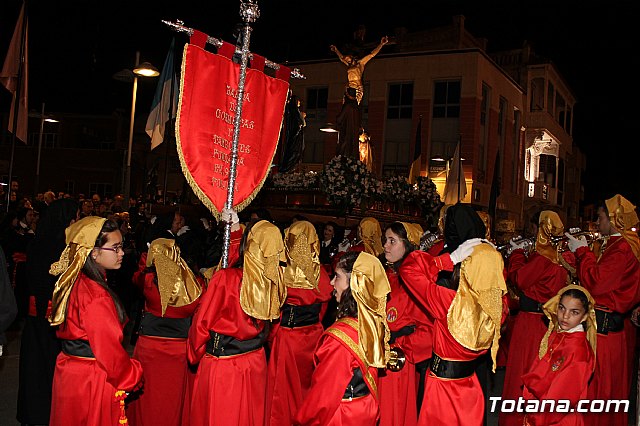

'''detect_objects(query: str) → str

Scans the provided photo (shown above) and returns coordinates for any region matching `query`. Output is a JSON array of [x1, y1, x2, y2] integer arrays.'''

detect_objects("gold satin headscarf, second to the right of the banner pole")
[[282, 220, 320, 289]]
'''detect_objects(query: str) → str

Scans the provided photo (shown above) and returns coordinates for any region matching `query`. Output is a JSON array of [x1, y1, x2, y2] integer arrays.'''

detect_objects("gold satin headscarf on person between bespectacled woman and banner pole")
[[147, 238, 202, 317]]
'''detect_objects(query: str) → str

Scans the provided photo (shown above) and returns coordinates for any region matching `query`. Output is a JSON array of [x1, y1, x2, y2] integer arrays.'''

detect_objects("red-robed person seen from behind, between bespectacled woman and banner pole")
[[127, 238, 203, 426]]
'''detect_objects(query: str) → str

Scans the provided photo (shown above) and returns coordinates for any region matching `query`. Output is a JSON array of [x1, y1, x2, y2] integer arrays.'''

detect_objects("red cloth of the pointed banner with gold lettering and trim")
[[176, 44, 289, 218]]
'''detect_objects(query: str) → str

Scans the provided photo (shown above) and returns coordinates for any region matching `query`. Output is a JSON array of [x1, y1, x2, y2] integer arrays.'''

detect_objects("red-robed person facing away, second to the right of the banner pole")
[[266, 220, 333, 426]]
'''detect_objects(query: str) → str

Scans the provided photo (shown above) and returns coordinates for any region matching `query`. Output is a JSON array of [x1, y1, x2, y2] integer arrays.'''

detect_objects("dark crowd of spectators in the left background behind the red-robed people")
[[0, 181, 358, 327]]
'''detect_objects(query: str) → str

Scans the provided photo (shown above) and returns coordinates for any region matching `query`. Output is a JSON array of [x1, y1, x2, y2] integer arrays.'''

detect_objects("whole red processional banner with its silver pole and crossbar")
[[162, 0, 304, 268]]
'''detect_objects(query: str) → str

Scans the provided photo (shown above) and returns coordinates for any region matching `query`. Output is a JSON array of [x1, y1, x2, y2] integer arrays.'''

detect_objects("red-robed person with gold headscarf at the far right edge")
[[567, 194, 640, 426]]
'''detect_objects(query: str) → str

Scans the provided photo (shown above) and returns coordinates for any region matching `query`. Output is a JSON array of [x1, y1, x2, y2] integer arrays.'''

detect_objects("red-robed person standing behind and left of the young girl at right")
[[499, 210, 575, 426]]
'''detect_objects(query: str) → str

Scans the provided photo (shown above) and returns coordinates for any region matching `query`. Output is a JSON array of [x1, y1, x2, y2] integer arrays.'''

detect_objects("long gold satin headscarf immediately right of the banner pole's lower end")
[[240, 220, 287, 321]]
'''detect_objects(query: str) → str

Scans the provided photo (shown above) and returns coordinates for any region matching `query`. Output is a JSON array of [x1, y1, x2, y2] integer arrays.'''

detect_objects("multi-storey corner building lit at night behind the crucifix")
[[290, 16, 585, 238]]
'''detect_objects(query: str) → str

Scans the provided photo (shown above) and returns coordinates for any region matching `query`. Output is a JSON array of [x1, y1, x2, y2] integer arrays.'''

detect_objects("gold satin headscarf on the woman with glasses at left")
[[48, 216, 107, 326]]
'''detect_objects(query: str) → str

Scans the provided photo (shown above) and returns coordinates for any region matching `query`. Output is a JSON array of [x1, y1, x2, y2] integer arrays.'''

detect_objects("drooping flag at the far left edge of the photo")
[[0, 2, 29, 144]]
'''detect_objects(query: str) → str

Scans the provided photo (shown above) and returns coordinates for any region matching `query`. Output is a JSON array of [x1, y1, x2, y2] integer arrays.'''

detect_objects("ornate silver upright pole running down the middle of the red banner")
[[221, 0, 260, 268]]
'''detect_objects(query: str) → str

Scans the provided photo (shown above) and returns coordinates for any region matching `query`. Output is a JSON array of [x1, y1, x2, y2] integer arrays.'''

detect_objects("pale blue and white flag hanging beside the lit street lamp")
[[145, 39, 178, 149]]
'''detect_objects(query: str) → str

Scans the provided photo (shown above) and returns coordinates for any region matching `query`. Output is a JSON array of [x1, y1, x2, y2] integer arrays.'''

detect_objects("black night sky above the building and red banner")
[[0, 0, 640, 204]]
